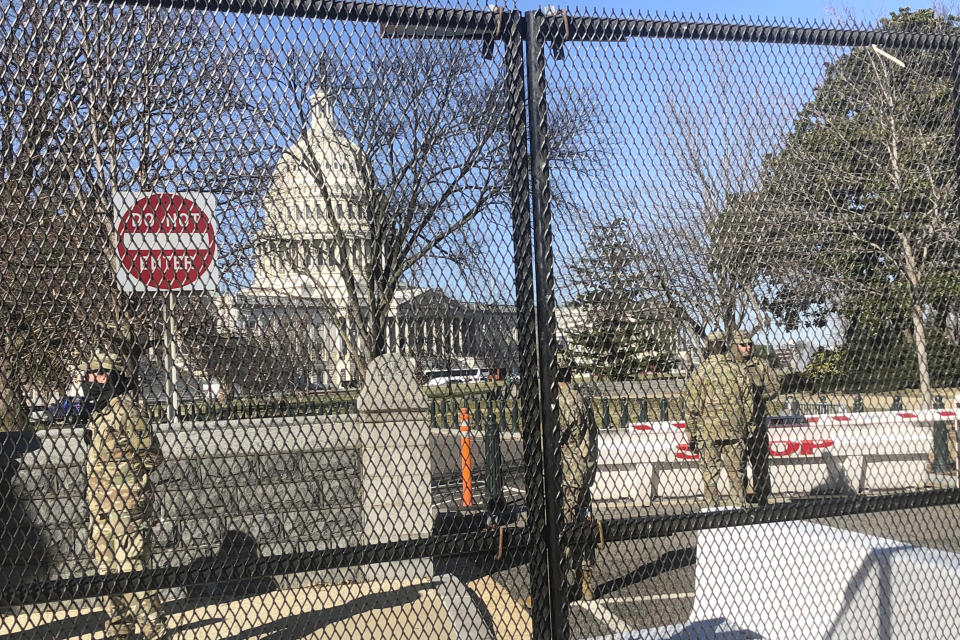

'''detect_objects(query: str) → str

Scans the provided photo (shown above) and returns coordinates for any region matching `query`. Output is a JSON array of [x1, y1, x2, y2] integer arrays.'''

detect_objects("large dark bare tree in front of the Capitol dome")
[[264, 41, 593, 374]]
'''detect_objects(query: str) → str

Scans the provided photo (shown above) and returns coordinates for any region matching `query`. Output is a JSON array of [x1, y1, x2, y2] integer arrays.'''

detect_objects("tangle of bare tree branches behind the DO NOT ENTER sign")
[[0, 0, 272, 396]]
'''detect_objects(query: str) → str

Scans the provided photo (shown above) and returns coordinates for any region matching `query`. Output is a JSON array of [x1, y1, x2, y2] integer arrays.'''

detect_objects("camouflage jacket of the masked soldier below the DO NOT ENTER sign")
[[87, 393, 163, 516]]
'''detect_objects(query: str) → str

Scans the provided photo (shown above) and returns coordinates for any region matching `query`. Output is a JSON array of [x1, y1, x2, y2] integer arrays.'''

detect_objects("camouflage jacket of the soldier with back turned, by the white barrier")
[[683, 353, 753, 440]]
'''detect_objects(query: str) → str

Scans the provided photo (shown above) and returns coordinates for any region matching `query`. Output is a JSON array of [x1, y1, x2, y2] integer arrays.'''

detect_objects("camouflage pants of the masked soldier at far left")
[[88, 511, 167, 640]]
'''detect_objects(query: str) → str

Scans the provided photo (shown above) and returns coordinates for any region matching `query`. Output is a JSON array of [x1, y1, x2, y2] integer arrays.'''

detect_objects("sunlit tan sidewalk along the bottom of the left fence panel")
[[0, 575, 531, 640]]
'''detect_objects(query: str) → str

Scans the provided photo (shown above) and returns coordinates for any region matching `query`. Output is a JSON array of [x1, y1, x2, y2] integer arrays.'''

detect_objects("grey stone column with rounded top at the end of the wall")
[[357, 354, 433, 581]]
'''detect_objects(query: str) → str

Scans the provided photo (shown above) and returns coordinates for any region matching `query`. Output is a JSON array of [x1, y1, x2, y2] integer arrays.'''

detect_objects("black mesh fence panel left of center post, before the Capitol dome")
[[0, 0, 547, 639]]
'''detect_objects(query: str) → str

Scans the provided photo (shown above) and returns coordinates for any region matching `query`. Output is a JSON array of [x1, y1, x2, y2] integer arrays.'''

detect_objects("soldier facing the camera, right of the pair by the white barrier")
[[732, 331, 780, 504]]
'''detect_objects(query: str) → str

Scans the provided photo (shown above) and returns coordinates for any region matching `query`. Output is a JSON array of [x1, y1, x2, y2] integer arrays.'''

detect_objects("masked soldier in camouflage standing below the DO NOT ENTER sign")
[[83, 353, 168, 640]]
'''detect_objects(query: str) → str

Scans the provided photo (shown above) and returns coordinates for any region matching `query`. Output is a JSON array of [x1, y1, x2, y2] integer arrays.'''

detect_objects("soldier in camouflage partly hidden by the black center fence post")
[[557, 359, 597, 600]]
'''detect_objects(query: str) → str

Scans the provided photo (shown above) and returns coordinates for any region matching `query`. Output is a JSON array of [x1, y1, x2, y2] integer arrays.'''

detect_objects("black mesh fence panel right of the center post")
[[538, 10, 960, 638]]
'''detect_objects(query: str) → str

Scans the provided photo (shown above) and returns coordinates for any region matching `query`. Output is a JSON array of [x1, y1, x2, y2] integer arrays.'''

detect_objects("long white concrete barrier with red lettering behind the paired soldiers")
[[593, 409, 936, 504]]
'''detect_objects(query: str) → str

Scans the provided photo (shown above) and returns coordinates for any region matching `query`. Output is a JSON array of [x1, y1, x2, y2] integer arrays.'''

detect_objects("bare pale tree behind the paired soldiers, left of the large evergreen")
[[600, 47, 796, 352]]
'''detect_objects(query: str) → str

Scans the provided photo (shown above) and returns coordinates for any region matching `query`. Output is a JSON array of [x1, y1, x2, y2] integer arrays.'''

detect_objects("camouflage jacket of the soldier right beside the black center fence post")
[[557, 384, 597, 488]]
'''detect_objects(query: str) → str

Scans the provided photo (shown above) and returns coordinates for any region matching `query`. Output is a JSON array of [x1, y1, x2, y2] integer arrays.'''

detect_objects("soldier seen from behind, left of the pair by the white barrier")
[[683, 334, 752, 508]]
